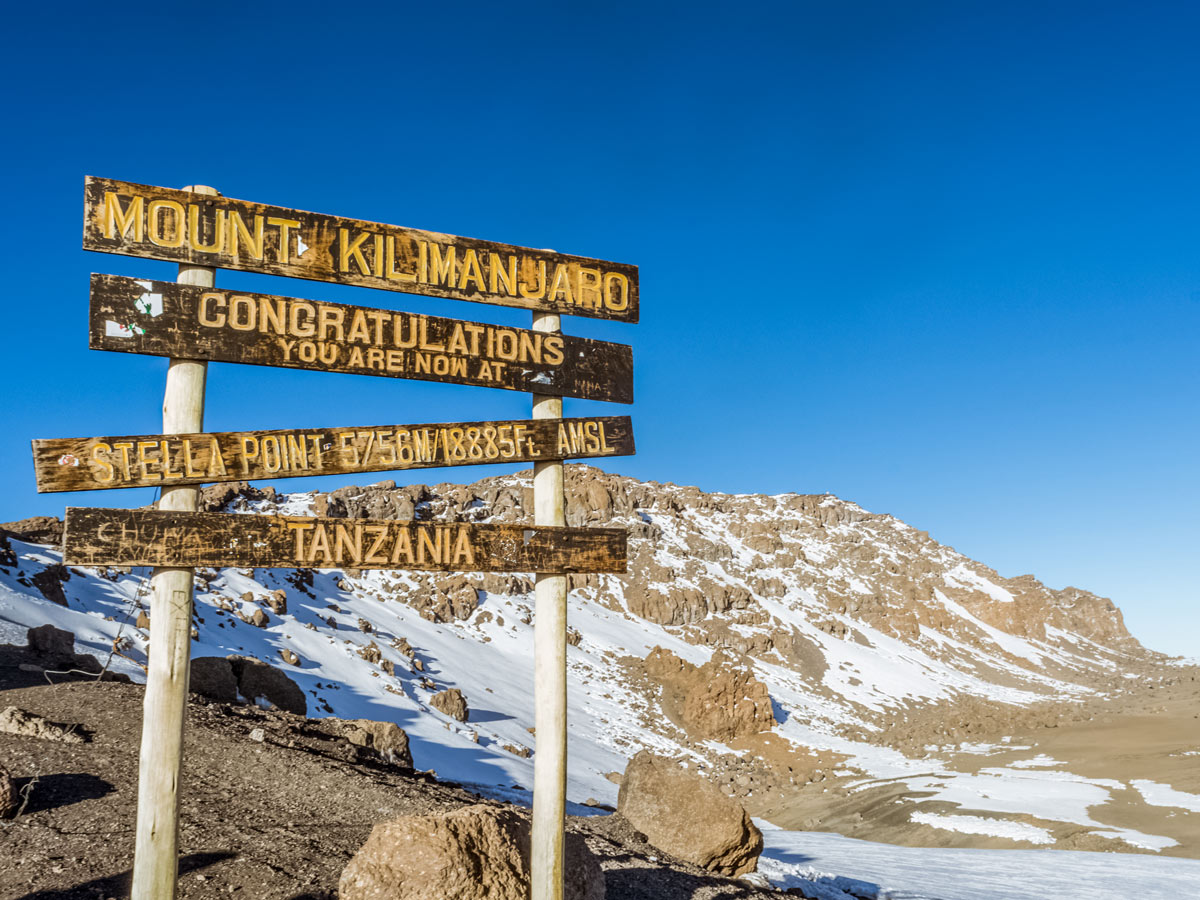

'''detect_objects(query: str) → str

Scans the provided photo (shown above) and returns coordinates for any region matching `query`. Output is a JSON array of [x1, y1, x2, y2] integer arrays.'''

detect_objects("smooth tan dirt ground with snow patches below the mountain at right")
[[746, 668, 1200, 859]]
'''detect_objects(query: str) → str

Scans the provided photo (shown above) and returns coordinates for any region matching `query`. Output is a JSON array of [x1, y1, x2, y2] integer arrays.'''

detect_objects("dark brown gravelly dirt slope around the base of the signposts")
[[0, 650, 780, 900]]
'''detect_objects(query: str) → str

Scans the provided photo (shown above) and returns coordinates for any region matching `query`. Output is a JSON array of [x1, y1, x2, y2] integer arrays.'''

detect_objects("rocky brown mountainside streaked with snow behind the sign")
[[0, 466, 1200, 851]]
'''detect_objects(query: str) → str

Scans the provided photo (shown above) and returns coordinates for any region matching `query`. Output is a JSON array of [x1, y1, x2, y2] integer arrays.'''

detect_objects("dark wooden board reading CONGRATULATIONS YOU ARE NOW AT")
[[89, 275, 634, 403]]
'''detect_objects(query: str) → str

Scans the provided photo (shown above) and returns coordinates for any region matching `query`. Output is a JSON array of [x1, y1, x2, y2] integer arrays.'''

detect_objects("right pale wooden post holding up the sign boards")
[[530, 312, 566, 900]]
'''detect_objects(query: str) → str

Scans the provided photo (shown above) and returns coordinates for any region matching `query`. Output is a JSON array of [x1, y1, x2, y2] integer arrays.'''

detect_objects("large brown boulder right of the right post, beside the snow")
[[617, 750, 762, 876]]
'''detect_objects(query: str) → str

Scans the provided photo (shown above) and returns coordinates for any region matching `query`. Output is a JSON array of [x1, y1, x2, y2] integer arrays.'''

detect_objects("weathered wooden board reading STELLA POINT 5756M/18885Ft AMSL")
[[34, 416, 634, 493]]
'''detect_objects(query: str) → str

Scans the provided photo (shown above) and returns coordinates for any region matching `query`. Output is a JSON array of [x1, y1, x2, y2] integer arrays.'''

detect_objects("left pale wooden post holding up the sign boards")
[[130, 185, 220, 900]]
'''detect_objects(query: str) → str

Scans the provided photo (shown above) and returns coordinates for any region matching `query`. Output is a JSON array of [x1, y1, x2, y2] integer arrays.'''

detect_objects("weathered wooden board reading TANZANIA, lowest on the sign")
[[62, 508, 625, 572]]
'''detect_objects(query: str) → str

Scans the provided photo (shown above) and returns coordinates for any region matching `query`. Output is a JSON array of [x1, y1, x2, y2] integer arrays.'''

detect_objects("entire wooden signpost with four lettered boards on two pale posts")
[[49, 178, 638, 900]]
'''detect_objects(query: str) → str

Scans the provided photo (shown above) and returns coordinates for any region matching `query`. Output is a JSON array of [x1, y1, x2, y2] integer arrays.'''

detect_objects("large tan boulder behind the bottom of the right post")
[[337, 804, 605, 900]]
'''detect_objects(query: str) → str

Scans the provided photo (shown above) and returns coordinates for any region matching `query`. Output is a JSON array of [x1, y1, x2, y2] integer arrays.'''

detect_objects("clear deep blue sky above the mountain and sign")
[[0, 1, 1200, 654]]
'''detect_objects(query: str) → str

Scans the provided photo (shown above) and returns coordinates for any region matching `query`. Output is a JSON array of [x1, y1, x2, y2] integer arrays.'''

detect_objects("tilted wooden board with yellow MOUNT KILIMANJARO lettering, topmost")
[[83, 176, 637, 323]]
